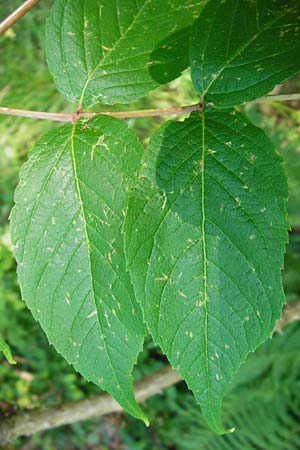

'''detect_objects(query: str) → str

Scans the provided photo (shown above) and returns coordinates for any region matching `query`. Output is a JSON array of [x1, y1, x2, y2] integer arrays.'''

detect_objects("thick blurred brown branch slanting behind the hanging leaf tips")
[[0, 301, 300, 445]]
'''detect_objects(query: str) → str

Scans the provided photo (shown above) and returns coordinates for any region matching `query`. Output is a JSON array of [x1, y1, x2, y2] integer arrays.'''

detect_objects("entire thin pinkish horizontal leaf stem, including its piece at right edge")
[[0, 94, 300, 122]]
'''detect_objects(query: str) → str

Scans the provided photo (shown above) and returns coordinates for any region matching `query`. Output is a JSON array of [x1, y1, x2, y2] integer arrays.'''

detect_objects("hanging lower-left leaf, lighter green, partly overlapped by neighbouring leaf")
[[11, 116, 147, 422]]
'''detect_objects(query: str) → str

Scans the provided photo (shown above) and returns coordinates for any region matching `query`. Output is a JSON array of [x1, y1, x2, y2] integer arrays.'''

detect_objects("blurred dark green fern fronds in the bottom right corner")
[[163, 324, 300, 450]]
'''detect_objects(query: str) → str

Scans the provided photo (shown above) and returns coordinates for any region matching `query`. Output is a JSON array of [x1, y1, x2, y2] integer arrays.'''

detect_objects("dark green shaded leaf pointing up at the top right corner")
[[190, 0, 300, 108]]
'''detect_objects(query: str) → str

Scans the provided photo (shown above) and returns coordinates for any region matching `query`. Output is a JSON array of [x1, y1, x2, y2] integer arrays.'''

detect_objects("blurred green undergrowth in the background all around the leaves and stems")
[[0, 0, 300, 450]]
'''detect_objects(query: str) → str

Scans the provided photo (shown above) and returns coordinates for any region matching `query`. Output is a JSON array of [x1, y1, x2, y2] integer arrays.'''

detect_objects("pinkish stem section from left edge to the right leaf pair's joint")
[[0, 103, 201, 122]]
